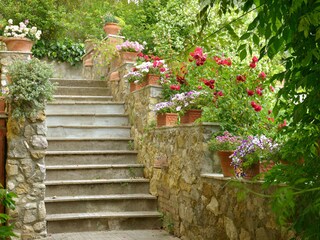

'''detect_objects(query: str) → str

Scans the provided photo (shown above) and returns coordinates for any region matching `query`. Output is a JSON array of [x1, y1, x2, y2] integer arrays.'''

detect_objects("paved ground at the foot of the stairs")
[[47, 230, 179, 240]]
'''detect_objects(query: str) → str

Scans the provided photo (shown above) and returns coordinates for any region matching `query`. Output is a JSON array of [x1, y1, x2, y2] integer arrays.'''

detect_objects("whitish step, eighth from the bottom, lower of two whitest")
[[47, 113, 129, 126]]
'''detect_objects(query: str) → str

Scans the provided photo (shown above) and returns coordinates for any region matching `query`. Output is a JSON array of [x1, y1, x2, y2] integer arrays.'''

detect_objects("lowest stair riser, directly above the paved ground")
[[47, 217, 161, 233]]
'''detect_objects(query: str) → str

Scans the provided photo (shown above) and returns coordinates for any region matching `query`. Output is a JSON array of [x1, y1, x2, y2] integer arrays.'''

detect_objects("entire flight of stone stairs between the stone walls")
[[45, 79, 161, 233]]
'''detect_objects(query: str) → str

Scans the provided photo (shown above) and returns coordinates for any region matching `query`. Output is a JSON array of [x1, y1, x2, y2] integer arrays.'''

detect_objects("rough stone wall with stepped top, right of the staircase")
[[104, 59, 288, 240]]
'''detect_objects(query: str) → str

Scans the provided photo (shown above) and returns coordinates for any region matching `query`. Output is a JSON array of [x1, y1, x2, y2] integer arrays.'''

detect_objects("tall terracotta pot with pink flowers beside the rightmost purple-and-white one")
[[209, 131, 241, 177]]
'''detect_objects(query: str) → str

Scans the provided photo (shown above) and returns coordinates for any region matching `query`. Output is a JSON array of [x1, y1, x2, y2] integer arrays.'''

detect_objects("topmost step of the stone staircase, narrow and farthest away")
[[50, 78, 107, 87]]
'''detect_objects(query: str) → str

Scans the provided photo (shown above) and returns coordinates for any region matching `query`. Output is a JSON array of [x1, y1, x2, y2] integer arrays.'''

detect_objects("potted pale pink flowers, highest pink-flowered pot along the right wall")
[[116, 40, 144, 62]]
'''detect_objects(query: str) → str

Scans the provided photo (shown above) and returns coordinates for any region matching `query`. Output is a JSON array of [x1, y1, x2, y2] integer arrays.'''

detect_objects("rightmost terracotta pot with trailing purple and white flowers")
[[231, 135, 279, 179]]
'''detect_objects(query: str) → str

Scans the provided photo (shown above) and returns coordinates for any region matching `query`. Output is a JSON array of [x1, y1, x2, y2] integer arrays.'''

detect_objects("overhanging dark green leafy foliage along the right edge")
[[200, 0, 320, 239]]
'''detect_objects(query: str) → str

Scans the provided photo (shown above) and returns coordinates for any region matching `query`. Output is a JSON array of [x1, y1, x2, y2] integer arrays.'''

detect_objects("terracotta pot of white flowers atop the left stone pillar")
[[2, 19, 41, 52]]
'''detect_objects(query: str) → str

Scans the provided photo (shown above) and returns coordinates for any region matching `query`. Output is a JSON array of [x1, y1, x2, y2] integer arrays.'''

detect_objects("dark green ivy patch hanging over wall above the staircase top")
[[32, 38, 85, 65]]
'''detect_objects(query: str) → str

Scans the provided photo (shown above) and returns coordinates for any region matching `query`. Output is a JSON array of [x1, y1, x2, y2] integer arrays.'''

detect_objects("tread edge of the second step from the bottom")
[[44, 193, 157, 202]]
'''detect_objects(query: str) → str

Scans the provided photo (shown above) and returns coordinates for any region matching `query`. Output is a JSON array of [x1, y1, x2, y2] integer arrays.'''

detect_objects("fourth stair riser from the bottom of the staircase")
[[46, 168, 143, 181]]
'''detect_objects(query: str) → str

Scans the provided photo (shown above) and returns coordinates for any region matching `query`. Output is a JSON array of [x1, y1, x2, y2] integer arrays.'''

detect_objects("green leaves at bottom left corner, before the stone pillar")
[[0, 185, 17, 240]]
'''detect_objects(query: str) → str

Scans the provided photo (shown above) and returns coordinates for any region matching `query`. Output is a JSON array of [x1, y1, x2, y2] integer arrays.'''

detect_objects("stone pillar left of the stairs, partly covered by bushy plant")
[[0, 51, 48, 239]]
